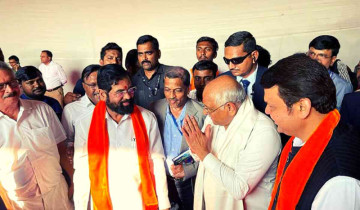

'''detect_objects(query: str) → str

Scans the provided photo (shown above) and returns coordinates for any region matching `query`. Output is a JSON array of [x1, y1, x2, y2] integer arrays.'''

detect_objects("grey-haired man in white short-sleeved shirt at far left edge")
[[0, 62, 73, 209]]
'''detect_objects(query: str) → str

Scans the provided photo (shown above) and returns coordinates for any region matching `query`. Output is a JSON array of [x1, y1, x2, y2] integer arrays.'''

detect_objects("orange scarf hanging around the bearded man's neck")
[[88, 101, 158, 210]]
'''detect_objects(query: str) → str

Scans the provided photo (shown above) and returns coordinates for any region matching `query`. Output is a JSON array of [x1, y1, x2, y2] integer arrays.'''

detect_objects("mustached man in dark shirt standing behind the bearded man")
[[131, 35, 171, 109]]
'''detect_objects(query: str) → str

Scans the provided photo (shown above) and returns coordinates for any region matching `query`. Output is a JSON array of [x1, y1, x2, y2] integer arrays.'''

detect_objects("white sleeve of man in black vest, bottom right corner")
[[311, 176, 360, 210]]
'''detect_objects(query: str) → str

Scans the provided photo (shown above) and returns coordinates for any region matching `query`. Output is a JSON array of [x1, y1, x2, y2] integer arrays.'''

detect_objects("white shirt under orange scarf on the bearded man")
[[74, 107, 170, 210]]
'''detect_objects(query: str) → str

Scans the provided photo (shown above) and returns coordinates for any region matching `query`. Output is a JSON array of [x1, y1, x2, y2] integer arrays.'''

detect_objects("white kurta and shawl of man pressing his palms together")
[[194, 98, 281, 210]]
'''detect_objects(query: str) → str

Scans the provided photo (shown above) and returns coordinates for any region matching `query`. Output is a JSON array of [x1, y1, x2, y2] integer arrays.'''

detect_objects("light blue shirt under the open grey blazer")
[[164, 104, 186, 159]]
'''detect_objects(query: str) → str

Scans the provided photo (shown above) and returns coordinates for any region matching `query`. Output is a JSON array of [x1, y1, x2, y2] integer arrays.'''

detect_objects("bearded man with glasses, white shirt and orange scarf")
[[74, 64, 170, 210]]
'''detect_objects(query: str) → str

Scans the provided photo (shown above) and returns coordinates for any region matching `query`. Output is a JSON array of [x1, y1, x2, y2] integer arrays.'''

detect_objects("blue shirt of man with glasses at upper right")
[[328, 70, 352, 110]]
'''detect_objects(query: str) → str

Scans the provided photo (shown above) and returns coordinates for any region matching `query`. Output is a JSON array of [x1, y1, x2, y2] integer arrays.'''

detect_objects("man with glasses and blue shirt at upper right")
[[307, 35, 353, 110]]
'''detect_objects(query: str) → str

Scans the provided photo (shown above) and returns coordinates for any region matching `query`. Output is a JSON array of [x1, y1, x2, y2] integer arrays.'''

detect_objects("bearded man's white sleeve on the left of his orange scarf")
[[73, 120, 90, 209]]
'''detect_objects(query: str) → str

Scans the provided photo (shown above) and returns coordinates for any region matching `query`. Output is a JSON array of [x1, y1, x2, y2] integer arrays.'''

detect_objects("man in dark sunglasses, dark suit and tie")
[[220, 31, 267, 113]]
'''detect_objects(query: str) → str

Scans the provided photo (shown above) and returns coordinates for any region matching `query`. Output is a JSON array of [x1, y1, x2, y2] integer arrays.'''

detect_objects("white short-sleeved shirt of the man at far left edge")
[[0, 99, 68, 209]]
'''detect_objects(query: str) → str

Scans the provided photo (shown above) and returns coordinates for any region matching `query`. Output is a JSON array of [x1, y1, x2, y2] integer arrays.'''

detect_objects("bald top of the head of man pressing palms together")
[[203, 75, 246, 106]]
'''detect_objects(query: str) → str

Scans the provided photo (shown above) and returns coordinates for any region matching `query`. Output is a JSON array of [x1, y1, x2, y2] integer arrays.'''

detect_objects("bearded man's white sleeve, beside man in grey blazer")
[[143, 112, 170, 209]]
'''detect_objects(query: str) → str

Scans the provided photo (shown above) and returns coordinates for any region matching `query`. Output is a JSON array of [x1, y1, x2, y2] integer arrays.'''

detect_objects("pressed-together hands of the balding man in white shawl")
[[181, 115, 212, 160]]
